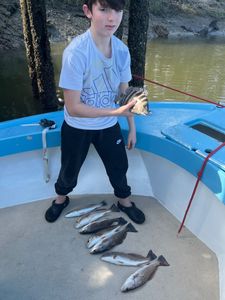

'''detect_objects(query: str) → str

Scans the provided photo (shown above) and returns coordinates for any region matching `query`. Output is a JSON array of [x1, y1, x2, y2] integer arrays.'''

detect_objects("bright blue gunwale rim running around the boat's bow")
[[0, 102, 225, 204]]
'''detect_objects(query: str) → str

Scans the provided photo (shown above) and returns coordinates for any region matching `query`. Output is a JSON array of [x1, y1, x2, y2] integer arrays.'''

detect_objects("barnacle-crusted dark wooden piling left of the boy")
[[20, 0, 57, 111]]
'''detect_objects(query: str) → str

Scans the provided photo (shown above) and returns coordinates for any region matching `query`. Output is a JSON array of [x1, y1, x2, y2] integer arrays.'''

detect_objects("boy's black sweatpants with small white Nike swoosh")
[[55, 121, 131, 198]]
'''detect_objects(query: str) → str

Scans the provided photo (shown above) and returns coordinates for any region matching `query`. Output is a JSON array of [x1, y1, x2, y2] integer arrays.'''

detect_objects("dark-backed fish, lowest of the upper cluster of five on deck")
[[90, 223, 137, 254]]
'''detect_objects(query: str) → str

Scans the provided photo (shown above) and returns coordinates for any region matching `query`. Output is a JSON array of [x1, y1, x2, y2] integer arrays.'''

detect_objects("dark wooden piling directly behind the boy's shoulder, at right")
[[128, 0, 149, 87]]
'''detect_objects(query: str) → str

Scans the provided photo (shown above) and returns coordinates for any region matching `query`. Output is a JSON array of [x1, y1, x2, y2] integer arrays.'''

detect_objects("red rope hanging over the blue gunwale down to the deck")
[[177, 142, 225, 234]]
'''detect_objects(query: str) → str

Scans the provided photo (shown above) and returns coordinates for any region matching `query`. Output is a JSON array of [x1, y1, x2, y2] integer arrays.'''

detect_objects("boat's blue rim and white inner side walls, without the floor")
[[0, 103, 225, 300]]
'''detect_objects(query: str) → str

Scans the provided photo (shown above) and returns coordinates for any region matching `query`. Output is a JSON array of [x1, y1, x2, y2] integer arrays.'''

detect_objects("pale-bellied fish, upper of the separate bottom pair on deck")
[[101, 250, 157, 267]]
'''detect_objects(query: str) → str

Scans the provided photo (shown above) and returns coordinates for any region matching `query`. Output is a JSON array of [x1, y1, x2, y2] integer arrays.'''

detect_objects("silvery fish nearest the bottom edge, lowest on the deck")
[[121, 255, 169, 292]]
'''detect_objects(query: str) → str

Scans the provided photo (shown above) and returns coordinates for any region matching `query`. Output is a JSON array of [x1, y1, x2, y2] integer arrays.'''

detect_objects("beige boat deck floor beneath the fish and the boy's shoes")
[[0, 195, 219, 300]]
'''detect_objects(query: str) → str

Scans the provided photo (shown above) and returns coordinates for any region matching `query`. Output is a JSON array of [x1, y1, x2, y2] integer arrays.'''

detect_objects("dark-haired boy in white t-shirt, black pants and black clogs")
[[45, 0, 145, 224]]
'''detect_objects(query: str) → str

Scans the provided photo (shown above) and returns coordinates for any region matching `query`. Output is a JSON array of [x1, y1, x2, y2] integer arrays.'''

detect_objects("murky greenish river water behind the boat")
[[0, 38, 225, 121]]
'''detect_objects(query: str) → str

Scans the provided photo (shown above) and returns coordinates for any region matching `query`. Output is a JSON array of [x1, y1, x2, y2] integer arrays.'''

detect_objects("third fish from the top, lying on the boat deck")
[[79, 217, 127, 234]]
